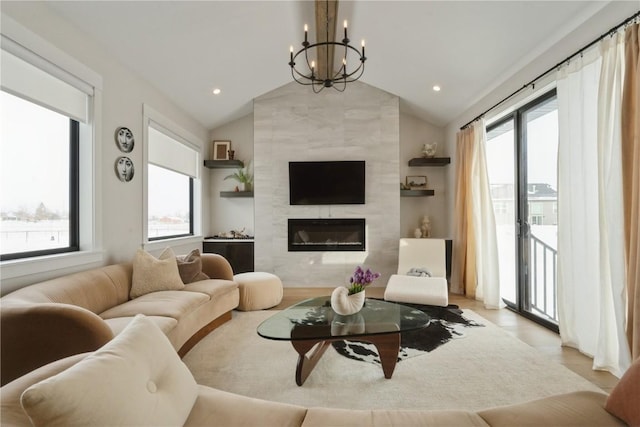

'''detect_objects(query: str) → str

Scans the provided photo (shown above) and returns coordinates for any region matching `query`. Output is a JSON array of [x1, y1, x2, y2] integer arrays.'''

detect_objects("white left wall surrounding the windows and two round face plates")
[[1, 2, 210, 294]]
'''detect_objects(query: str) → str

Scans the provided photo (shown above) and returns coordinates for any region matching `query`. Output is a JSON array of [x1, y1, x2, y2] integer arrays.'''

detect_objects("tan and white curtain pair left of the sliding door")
[[453, 120, 504, 308]]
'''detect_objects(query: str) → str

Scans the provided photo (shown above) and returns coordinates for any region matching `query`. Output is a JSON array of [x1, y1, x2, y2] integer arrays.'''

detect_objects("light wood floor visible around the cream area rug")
[[273, 287, 618, 392]]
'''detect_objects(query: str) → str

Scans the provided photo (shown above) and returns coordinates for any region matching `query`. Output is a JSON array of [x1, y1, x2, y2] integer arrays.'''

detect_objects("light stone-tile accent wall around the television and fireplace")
[[253, 82, 400, 287]]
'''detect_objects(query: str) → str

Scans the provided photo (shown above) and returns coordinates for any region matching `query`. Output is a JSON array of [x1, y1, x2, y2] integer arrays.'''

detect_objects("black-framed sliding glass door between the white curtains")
[[487, 91, 558, 330]]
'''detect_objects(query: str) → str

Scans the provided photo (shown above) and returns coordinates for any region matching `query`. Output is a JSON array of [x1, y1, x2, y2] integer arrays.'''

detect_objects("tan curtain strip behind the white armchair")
[[451, 126, 477, 299]]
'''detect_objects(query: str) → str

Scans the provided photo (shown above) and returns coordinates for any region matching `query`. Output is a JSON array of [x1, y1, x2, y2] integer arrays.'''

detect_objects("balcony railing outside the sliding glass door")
[[529, 234, 558, 323]]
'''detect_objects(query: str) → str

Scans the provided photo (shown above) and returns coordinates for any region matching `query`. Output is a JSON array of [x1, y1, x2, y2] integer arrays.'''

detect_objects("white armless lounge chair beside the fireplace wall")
[[384, 239, 449, 307]]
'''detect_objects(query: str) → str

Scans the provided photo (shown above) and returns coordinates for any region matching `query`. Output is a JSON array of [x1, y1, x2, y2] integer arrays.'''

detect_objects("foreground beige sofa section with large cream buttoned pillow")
[[0, 316, 640, 427]]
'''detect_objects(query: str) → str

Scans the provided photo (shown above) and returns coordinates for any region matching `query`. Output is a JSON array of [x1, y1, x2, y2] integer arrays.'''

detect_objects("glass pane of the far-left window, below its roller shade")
[[0, 91, 79, 260]]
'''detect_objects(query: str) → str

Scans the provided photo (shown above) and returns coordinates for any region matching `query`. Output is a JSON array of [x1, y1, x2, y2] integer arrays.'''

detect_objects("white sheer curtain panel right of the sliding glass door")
[[557, 31, 630, 376]]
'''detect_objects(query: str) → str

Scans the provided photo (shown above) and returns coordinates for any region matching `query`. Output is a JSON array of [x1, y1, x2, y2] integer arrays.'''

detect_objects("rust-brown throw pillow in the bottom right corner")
[[604, 358, 640, 426]]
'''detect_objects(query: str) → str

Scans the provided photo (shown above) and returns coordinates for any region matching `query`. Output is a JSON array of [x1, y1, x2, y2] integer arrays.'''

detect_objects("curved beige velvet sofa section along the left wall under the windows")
[[0, 253, 239, 385]]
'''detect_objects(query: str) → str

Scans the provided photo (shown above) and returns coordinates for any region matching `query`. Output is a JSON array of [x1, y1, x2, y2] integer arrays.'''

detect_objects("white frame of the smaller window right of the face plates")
[[142, 104, 204, 251]]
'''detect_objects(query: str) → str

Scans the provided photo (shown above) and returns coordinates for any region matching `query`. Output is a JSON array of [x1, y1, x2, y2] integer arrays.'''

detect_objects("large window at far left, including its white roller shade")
[[0, 43, 92, 261]]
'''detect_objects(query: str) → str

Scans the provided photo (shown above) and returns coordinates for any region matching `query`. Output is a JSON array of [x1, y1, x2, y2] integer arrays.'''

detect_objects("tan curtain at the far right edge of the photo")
[[622, 24, 640, 360]]
